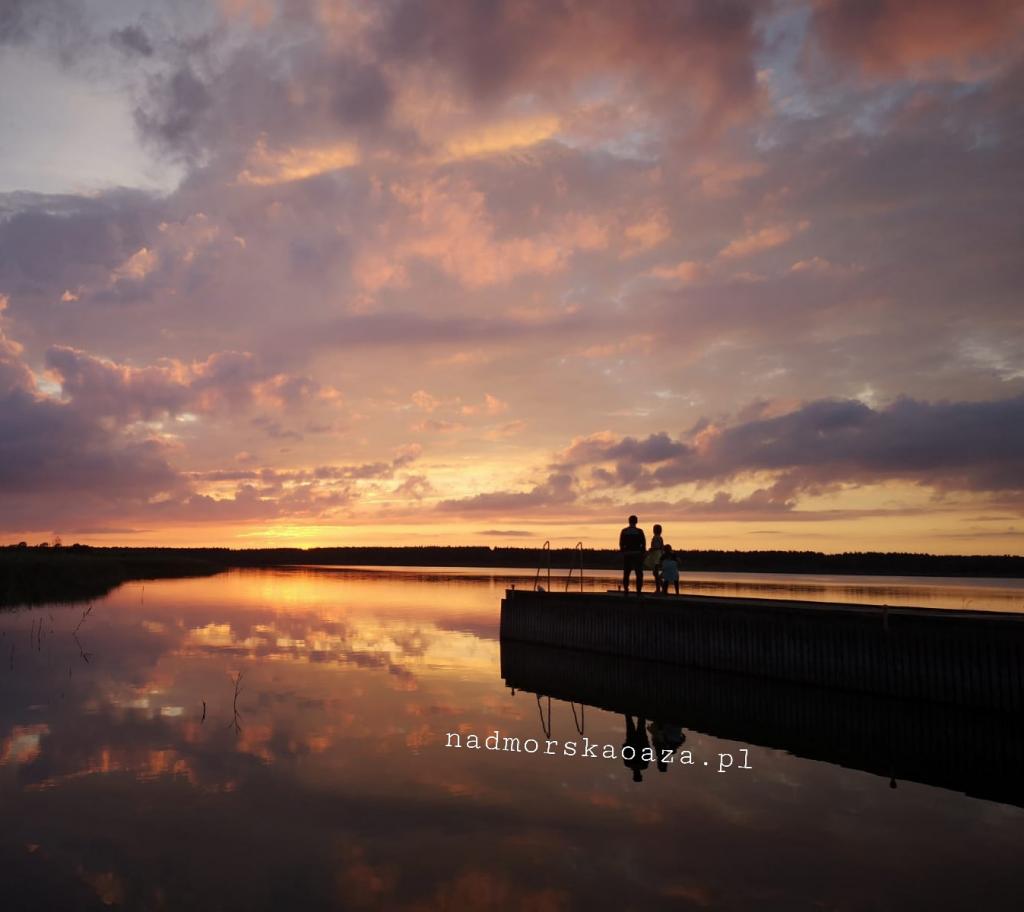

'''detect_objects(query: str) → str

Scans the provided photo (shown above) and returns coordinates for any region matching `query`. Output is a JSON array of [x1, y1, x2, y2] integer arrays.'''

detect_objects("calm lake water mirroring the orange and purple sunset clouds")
[[0, 568, 1024, 910]]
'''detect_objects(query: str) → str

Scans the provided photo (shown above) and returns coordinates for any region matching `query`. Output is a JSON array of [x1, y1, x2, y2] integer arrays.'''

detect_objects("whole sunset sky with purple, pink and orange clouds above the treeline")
[[0, 0, 1024, 554]]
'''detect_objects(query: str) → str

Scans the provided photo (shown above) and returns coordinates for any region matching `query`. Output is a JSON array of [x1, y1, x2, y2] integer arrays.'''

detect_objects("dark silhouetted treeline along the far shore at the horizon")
[[0, 545, 1024, 581]]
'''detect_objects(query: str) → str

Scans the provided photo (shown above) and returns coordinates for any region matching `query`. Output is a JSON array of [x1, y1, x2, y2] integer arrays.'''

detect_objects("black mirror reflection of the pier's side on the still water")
[[501, 640, 1024, 807]]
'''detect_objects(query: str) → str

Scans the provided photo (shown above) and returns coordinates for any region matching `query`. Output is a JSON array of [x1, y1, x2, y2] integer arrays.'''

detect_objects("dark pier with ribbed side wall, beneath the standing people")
[[501, 590, 1024, 714]]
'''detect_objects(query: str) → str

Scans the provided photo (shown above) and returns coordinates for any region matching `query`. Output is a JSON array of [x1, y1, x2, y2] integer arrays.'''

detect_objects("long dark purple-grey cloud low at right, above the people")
[[564, 396, 1024, 503]]
